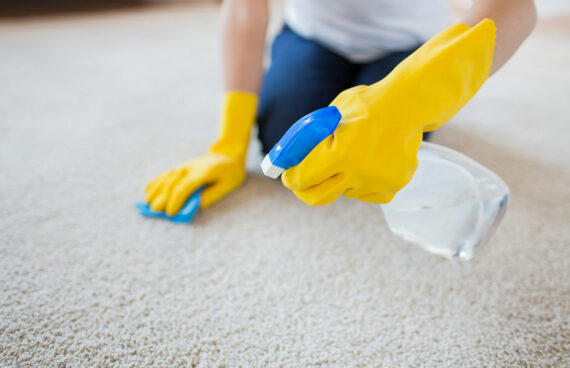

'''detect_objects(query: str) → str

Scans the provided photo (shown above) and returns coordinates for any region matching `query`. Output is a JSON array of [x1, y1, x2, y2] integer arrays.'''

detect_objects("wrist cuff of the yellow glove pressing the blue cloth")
[[209, 91, 258, 161]]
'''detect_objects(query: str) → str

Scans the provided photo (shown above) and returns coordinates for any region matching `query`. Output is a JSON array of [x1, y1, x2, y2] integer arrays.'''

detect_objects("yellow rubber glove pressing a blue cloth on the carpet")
[[146, 92, 257, 216]]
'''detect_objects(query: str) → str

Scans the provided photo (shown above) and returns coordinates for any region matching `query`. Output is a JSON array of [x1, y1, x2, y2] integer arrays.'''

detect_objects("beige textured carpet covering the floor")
[[0, 5, 570, 367]]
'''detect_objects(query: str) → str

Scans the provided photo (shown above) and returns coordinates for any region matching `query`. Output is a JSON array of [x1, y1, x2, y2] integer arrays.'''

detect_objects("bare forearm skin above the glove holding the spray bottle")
[[463, 0, 536, 74]]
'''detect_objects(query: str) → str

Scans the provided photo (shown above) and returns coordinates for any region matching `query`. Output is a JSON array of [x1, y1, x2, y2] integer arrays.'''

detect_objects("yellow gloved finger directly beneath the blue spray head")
[[281, 136, 338, 191]]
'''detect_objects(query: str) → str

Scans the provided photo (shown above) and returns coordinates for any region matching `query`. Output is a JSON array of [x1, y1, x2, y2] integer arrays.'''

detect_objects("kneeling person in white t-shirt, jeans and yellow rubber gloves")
[[146, 0, 536, 215]]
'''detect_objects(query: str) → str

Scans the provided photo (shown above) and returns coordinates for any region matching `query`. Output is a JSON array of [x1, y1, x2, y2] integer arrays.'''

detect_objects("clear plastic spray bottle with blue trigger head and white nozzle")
[[261, 106, 509, 260]]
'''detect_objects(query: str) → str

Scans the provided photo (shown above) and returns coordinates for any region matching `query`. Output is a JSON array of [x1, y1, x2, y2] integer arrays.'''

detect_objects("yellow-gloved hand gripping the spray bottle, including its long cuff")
[[281, 19, 495, 205]]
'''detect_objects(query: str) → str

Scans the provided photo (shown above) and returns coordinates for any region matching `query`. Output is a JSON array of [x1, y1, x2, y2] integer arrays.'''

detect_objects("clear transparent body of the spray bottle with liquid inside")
[[382, 142, 509, 260]]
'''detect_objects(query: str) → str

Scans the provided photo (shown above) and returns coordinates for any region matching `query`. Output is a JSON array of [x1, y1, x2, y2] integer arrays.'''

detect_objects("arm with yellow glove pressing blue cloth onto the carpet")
[[146, 0, 269, 216]]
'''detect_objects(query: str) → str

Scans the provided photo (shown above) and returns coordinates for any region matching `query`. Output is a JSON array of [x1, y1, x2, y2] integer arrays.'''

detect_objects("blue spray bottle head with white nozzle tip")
[[261, 106, 342, 179]]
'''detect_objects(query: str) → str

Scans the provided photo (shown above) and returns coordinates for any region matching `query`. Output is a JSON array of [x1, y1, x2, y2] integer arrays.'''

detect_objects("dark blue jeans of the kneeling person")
[[257, 25, 424, 153]]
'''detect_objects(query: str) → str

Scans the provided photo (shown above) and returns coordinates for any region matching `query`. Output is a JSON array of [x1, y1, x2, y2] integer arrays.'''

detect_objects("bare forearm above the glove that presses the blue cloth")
[[222, 0, 269, 94]]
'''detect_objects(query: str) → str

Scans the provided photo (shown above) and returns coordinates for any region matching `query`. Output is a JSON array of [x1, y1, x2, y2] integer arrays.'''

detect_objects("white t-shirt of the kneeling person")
[[285, 0, 451, 62]]
